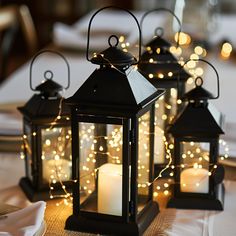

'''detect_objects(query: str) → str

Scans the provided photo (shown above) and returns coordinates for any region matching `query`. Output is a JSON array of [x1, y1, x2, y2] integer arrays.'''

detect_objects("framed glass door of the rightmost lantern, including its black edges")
[[176, 139, 214, 197]]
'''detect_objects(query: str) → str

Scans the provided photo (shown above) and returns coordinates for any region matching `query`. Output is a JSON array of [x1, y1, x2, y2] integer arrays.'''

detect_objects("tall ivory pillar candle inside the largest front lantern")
[[98, 163, 122, 216]]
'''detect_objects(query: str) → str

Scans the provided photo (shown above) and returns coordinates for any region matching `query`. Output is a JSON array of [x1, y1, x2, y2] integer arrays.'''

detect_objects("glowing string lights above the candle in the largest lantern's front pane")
[[79, 122, 123, 197]]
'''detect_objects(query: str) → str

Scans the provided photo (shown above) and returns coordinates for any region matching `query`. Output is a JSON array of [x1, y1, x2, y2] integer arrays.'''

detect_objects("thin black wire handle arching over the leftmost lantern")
[[29, 49, 70, 91]]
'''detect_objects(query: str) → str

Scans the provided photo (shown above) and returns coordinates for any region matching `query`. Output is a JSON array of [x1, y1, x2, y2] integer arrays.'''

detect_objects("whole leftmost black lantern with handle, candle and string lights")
[[18, 50, 72, 201]]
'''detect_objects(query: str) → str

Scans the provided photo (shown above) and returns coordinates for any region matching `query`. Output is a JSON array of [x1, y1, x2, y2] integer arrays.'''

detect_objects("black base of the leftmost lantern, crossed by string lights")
[[19, 177, 71, 202]]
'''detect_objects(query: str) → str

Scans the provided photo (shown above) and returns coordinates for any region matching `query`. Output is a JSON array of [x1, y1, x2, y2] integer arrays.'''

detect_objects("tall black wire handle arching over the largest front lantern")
[[86, 6, 142, 64]]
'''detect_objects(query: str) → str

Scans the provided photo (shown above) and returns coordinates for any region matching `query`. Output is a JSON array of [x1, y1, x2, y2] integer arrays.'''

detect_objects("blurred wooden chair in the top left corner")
[[0, 5, 38, 83]]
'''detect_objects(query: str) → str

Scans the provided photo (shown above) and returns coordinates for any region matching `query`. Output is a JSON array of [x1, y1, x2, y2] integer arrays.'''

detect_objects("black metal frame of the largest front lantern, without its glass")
[[65, 6, 163, 235]]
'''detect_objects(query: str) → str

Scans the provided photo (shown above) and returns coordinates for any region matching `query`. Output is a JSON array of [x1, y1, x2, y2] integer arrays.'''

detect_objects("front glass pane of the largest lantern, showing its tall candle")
[[79, 122, 123, 216]]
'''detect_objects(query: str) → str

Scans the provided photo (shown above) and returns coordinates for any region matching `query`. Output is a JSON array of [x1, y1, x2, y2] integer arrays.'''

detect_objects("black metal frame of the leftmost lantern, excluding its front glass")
[[18, 50, 72, 202]]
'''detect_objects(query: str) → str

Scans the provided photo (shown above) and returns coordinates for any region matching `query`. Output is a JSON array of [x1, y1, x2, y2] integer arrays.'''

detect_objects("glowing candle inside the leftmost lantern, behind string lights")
[[42, 159, 72, 182]]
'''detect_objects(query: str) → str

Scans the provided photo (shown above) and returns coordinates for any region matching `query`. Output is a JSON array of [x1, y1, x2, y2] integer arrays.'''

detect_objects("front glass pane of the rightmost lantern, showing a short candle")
[[180, 142, 210, 193]]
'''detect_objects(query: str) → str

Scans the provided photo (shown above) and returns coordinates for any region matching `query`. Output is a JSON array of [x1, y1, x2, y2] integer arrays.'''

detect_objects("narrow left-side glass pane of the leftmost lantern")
[[24, 123, 33, 181]]
